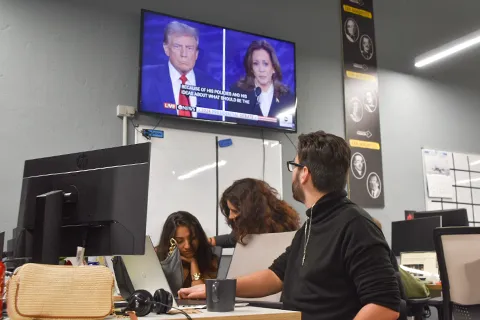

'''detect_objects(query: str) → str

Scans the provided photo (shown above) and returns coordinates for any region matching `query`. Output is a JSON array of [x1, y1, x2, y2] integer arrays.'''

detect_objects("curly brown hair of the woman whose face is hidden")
[[220, 178, 300, 244]]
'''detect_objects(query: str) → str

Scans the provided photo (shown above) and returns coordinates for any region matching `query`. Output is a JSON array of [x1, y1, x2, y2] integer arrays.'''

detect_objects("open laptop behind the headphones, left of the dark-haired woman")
[[122, 236, 207, 309]]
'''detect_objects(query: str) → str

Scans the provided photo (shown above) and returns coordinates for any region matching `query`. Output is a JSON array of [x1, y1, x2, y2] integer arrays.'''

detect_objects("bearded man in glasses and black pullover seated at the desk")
[[179, 131, 400, 320]]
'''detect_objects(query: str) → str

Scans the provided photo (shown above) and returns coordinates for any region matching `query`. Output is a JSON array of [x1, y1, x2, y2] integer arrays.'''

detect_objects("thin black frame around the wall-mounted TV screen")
[[137, 9, 298, 133]]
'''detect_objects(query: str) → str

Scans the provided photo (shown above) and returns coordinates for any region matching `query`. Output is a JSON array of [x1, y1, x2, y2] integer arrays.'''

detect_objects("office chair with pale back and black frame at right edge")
[[434, 227, 480, 320]]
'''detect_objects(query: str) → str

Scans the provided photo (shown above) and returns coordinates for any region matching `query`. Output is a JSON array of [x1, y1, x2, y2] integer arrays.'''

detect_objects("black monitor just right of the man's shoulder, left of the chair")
[[392, 216, 442, 256]]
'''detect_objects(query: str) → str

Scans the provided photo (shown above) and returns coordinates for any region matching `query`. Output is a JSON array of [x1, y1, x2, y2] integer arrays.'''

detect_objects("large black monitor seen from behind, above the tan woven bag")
[[13, 143, 150, 264]]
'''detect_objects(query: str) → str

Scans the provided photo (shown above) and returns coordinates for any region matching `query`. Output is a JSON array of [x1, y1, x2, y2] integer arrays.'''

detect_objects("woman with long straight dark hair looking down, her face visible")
[[157, 211, 218, 288]]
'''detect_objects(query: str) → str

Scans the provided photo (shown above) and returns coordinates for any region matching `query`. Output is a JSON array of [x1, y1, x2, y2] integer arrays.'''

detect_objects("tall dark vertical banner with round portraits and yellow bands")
[[341, 0, 385, 208]]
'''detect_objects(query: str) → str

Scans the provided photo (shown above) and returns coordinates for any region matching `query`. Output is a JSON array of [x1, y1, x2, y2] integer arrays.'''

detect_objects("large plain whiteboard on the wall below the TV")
[[135, 126, 283, 245]]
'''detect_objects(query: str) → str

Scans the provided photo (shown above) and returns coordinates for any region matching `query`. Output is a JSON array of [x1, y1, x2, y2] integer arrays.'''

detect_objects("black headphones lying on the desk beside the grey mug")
[[122, 289, 191, 319]]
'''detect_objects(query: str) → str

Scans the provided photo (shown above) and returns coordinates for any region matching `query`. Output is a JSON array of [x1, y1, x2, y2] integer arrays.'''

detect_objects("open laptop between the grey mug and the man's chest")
[[227, 231, 296, 309]]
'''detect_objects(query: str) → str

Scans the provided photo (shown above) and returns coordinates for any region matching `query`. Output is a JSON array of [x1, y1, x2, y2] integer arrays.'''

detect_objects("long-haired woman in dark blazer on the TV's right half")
[[227, 40, 296, 127]]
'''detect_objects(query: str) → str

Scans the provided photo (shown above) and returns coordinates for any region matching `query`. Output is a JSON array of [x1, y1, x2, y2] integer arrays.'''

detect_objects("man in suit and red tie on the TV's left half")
[[140, 21, 222, 120]]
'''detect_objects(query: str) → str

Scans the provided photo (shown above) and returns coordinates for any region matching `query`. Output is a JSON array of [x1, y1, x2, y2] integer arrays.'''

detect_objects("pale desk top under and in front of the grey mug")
[[145, 307, 302, 320]]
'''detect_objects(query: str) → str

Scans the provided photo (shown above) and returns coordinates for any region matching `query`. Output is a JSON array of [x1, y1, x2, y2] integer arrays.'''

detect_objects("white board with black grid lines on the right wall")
[[422, 149, 480, 226]]
